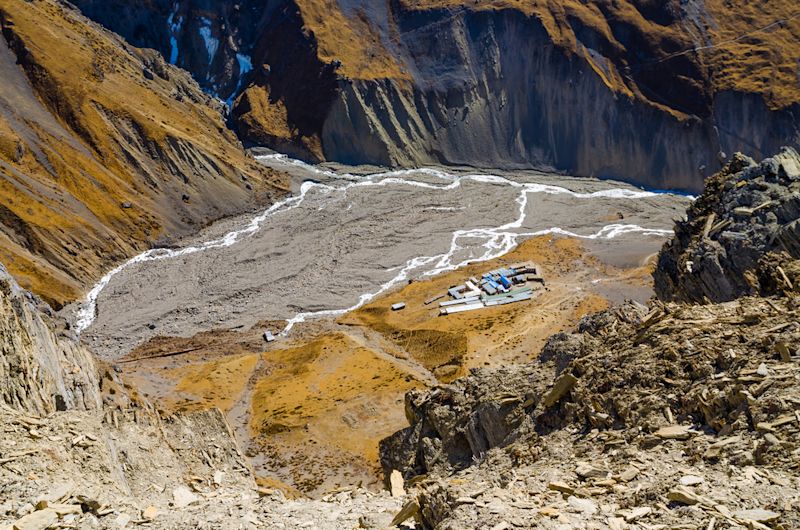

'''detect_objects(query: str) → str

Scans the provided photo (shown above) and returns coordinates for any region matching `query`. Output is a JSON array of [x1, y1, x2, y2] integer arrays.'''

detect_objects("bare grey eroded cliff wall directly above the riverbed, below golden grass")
[[322, 11, 800, 191]]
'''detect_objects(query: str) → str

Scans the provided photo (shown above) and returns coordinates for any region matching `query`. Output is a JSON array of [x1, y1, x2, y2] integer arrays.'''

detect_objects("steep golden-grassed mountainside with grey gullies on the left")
[[0, 0, 285, 307]]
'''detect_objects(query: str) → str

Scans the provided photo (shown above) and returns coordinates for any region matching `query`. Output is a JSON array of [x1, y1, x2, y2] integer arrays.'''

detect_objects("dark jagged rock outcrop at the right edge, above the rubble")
[[653, 148, 800, 302]]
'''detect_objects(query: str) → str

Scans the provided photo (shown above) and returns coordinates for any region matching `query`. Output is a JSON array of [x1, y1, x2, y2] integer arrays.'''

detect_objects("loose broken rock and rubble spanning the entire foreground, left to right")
[[0, 151, 800, 530]]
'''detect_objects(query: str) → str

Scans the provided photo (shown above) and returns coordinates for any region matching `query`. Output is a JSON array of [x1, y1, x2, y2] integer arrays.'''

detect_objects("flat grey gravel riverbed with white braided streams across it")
[[77, 154, 689, 359]]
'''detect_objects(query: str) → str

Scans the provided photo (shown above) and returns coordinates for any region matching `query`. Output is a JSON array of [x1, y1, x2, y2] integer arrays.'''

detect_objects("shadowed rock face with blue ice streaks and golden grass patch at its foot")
[[76, 0, 339, 157]]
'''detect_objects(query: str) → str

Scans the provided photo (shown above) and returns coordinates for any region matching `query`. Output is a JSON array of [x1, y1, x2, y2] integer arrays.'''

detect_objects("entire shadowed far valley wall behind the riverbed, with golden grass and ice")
[[72, 0, 800, 190]]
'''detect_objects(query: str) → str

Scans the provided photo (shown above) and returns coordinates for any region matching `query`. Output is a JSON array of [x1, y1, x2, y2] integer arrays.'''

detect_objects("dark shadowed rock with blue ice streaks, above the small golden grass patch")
[[69, 0, 335, 111]]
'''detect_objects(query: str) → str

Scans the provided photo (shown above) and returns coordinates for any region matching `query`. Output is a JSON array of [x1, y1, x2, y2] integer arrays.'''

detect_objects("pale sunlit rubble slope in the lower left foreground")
[[0, 265, 399, 530]]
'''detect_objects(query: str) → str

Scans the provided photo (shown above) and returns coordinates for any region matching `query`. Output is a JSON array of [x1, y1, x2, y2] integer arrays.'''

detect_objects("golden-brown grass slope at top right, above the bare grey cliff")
[[399, 0, 800, 115]]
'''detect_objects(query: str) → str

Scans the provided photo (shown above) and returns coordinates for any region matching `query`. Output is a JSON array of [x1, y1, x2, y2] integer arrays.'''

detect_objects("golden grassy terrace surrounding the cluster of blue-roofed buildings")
[[119, 236, 664, 495]]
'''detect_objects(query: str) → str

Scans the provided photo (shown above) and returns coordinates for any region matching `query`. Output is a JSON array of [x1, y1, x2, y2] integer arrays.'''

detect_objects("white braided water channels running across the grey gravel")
[[76, 154, 672, 334]]
